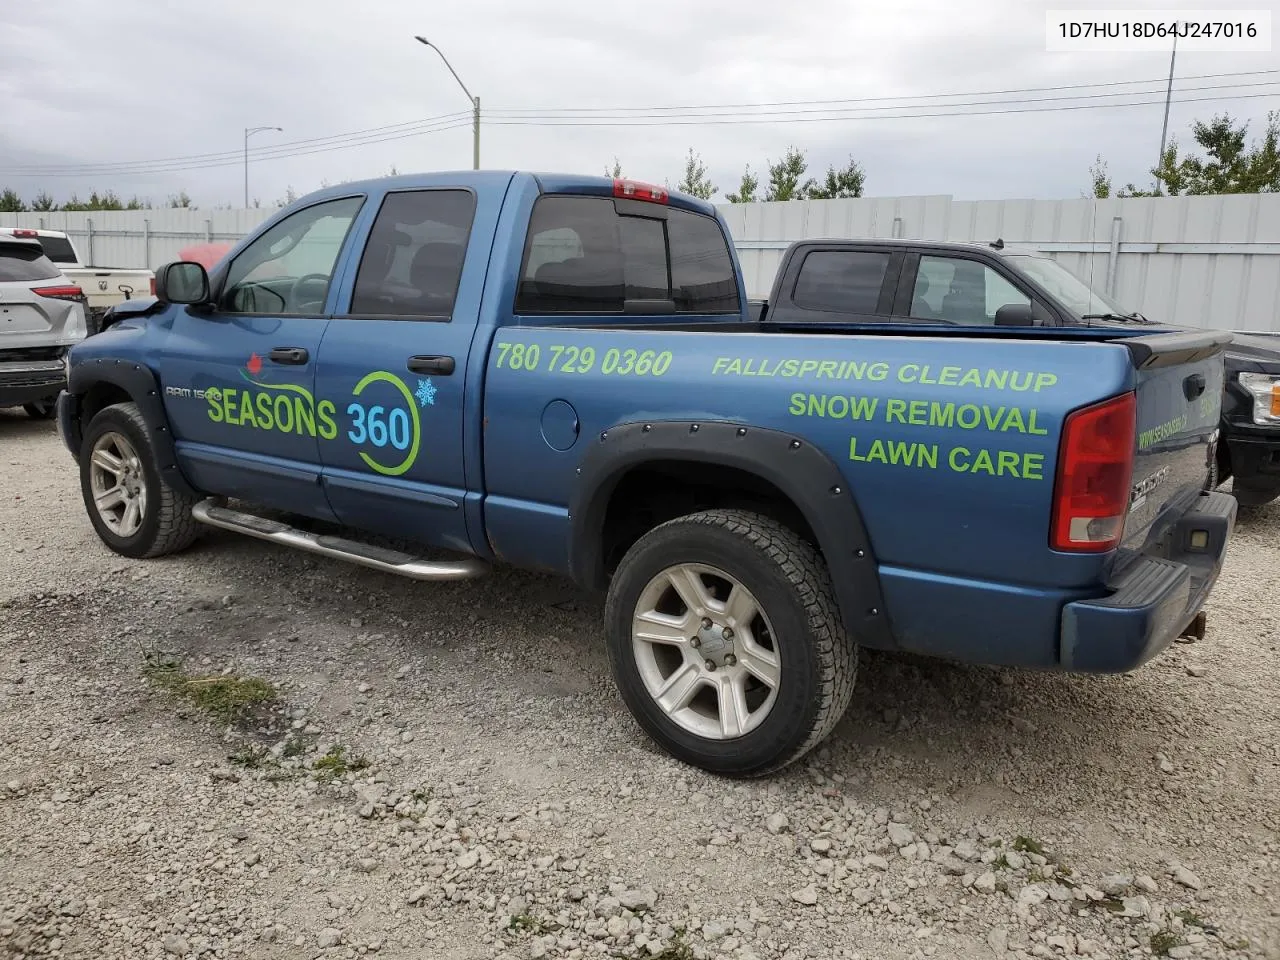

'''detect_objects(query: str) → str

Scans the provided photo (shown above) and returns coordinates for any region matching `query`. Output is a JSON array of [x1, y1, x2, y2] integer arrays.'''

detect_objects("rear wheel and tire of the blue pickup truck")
[[605, 509, 858, 777]]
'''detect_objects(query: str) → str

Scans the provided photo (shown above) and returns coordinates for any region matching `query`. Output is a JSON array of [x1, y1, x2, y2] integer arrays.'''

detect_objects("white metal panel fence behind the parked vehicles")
[[0, 193, 1280, 332]]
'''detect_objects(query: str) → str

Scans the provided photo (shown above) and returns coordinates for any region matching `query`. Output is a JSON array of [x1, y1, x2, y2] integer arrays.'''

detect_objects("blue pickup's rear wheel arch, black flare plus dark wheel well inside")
[[570, 421, 897, 649]]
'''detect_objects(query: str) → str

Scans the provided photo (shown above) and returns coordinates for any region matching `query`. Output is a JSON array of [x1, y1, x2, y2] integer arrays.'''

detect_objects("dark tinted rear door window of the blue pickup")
[[351, 189, 475, 317]]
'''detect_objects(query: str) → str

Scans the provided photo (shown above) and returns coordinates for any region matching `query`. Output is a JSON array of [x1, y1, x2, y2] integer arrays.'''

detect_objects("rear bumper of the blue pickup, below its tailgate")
[[1060, 493, 1236, 673]]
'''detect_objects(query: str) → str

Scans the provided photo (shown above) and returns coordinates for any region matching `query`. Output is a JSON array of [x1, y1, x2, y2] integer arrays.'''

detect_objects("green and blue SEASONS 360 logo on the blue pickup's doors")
[[205, 353, 436, 476]]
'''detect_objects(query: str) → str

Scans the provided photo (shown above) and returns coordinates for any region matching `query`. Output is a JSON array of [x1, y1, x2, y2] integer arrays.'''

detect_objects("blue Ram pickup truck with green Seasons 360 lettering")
[[58, 172, 1235, 776]]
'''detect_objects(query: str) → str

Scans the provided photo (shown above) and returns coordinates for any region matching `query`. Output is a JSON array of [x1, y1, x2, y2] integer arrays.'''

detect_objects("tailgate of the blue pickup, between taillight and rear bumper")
[[1121, 332, 1230, 549]]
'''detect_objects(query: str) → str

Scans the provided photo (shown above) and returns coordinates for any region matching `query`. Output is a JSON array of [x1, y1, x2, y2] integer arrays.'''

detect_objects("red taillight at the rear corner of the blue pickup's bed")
[[1051, 393, 1138, 553]]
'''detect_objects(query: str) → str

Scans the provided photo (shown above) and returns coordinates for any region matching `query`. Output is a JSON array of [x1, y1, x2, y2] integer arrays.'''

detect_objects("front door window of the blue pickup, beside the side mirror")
[[220, 197, 365, 316]]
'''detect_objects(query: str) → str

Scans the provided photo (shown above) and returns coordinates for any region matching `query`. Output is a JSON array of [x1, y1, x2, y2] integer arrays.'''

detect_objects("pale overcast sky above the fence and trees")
[[0, 0, 1280, 206]]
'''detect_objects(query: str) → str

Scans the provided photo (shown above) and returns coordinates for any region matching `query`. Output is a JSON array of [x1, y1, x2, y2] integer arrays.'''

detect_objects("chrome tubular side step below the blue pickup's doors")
[[191, 500, 489, 580]]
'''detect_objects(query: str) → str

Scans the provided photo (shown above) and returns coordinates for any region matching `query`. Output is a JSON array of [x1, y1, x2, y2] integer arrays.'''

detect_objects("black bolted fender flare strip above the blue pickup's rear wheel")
[[570, 420, 897, 649]]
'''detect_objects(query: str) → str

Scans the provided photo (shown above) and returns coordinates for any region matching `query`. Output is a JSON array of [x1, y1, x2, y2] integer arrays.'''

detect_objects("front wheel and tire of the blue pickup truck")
[[79, 403, 201, 558]]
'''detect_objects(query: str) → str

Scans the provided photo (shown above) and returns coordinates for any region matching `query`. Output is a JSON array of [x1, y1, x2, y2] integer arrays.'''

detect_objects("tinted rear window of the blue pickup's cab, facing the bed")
[[516, 197, 739, 314]]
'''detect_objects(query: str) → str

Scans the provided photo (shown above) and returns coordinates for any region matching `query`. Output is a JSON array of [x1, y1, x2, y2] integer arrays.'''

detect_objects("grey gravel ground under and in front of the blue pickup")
[[0, 411, 1280, 960]]
